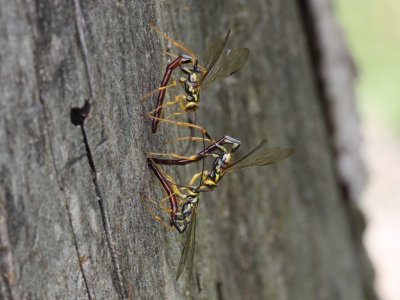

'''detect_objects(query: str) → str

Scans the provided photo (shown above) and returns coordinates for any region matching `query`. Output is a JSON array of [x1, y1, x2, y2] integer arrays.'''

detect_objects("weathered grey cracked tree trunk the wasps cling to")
[[0, 0, 375, 300]]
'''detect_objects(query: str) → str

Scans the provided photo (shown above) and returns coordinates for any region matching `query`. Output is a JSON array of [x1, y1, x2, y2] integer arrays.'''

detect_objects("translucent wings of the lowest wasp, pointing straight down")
[[176, 204, 197, 280]]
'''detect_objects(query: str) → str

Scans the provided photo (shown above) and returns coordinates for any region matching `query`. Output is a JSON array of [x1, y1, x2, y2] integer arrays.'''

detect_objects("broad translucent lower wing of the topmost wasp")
[[200, 48, 250, 89]]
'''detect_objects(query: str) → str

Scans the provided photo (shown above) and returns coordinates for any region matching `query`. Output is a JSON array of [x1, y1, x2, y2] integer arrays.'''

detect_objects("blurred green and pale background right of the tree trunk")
[[333, 0, 400, 300]]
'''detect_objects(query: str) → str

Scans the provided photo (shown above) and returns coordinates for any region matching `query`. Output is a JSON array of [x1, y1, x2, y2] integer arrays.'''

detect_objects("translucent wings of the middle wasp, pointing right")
[[226, 140, 293, 172]]
